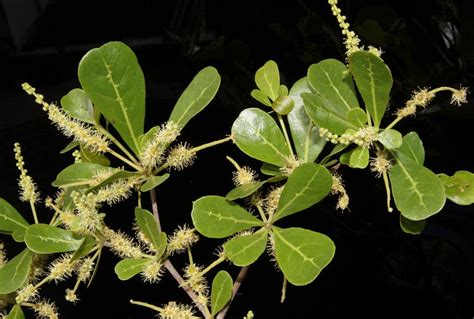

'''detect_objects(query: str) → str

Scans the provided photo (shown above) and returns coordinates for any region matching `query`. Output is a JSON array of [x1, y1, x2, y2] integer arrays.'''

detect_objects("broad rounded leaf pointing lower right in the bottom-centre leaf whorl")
[[273, 228, 336, 286]]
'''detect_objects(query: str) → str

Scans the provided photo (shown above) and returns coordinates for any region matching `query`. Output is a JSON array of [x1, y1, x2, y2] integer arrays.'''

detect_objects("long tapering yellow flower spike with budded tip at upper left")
[[22, 83, 109, 153]]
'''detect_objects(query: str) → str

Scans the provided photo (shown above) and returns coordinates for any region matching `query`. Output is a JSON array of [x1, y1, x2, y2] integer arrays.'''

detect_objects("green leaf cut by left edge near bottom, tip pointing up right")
[[0, 248, 33, 295]]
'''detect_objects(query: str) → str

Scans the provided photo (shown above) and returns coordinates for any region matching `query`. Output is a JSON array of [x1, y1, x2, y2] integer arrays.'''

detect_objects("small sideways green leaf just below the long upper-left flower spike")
[[52, 162, 107, 188]]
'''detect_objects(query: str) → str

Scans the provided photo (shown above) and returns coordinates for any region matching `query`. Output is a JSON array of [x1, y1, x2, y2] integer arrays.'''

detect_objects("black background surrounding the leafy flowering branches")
[[0, 0, 474, 318]]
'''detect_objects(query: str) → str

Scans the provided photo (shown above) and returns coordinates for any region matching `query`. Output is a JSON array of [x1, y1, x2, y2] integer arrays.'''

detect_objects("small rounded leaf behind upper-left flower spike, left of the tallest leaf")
[[61, 89, 95, 124]]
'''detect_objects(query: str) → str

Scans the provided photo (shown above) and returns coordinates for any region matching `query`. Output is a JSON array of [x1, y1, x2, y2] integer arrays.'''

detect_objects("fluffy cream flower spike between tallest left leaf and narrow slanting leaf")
[[140, 121, 180, 170]]
